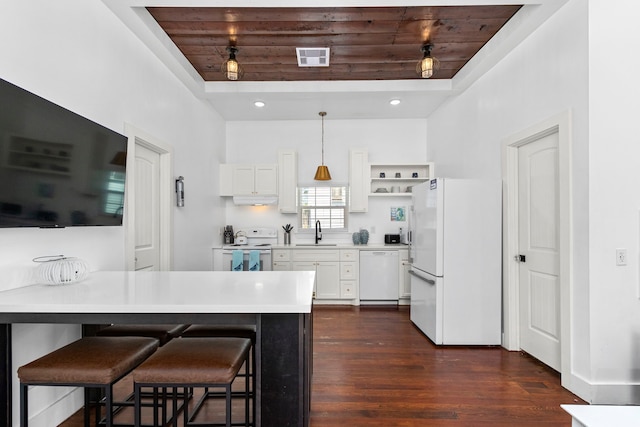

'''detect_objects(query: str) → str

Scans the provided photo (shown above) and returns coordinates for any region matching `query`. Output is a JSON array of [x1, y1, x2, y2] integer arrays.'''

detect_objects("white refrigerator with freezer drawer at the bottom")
[[409, 178, 502, 345]]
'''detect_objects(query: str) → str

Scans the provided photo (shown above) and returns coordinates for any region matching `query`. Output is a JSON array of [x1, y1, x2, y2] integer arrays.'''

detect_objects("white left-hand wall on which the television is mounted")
[[0, 0, 225, 427]]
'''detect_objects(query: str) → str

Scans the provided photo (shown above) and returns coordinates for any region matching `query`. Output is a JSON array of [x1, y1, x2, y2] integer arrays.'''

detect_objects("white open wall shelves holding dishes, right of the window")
[[369, 163, 435, 197]]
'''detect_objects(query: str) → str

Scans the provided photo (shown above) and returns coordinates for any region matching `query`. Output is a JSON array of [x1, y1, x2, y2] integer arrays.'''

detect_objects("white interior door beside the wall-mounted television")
[[134, 145, 160, 270]]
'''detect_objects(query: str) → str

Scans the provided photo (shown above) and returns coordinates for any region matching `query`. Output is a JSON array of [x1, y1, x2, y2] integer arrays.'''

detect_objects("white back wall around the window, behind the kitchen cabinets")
[[226, 118, 427, 243]]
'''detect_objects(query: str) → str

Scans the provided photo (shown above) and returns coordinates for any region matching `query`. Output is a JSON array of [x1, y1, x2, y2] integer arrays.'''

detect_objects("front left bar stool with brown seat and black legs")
[[18, 337, 158, 427]]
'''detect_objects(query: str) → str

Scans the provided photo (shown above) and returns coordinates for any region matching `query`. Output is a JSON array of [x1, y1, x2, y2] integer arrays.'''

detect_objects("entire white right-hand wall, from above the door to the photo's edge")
[[428, 0, 640, 404]]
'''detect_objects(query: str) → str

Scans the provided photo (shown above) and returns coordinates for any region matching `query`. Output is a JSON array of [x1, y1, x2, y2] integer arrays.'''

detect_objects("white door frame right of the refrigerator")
[[502, 110, 573, 382]]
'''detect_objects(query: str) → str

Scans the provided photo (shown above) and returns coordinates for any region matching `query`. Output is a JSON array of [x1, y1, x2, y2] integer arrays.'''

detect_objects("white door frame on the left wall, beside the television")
[[124, 123, 174, 271]]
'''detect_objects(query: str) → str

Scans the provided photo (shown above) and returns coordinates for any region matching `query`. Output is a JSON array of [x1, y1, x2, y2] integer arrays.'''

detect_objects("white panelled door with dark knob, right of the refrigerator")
[[518, 132, 561, 371]]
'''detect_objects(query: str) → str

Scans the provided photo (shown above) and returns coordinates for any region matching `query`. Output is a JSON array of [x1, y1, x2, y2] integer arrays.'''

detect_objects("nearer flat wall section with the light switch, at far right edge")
[[588, 0, 640, 404]]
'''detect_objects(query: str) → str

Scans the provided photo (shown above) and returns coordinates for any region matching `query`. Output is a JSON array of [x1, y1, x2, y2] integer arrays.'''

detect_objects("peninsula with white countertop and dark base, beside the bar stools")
[[0, 271, 315, 427]]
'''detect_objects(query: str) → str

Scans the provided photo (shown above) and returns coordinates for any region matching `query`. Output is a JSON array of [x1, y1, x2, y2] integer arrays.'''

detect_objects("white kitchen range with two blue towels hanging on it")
[[222, 227, 278, 271]]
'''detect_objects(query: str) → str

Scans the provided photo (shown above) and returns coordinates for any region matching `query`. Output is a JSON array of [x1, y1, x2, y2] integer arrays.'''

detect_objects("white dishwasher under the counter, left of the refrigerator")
[[360, 249, 400, 304]]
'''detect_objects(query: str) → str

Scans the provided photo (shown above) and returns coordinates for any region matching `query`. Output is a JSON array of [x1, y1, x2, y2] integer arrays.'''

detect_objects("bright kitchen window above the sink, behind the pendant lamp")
[[298, 185, 348, 231]]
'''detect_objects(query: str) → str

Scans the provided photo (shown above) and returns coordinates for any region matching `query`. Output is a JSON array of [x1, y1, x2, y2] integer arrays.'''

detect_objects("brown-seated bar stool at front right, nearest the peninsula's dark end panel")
[[132, 338, 255, 427]]
